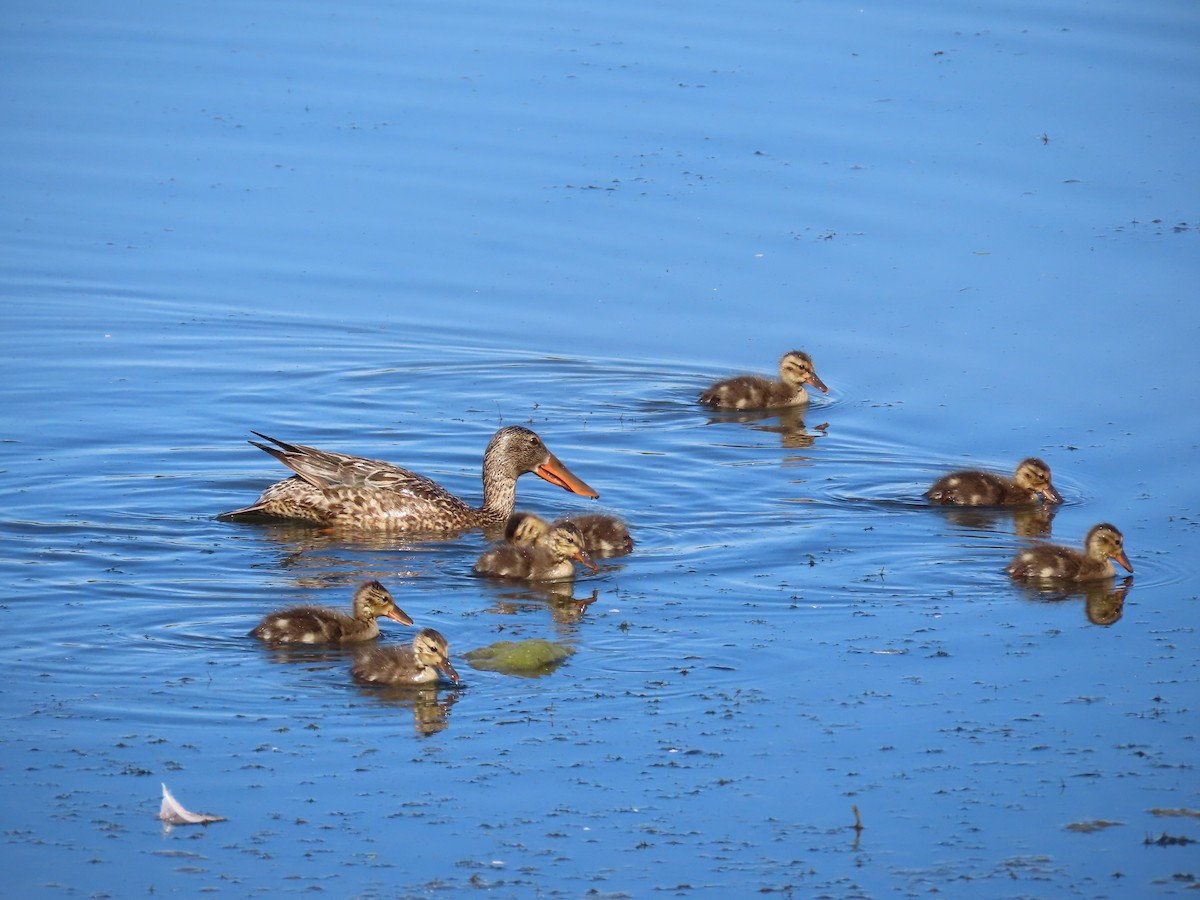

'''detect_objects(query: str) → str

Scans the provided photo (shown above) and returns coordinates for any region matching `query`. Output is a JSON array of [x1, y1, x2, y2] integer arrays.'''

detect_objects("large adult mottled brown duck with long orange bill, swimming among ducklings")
[[222, 425, 599, 532]]
